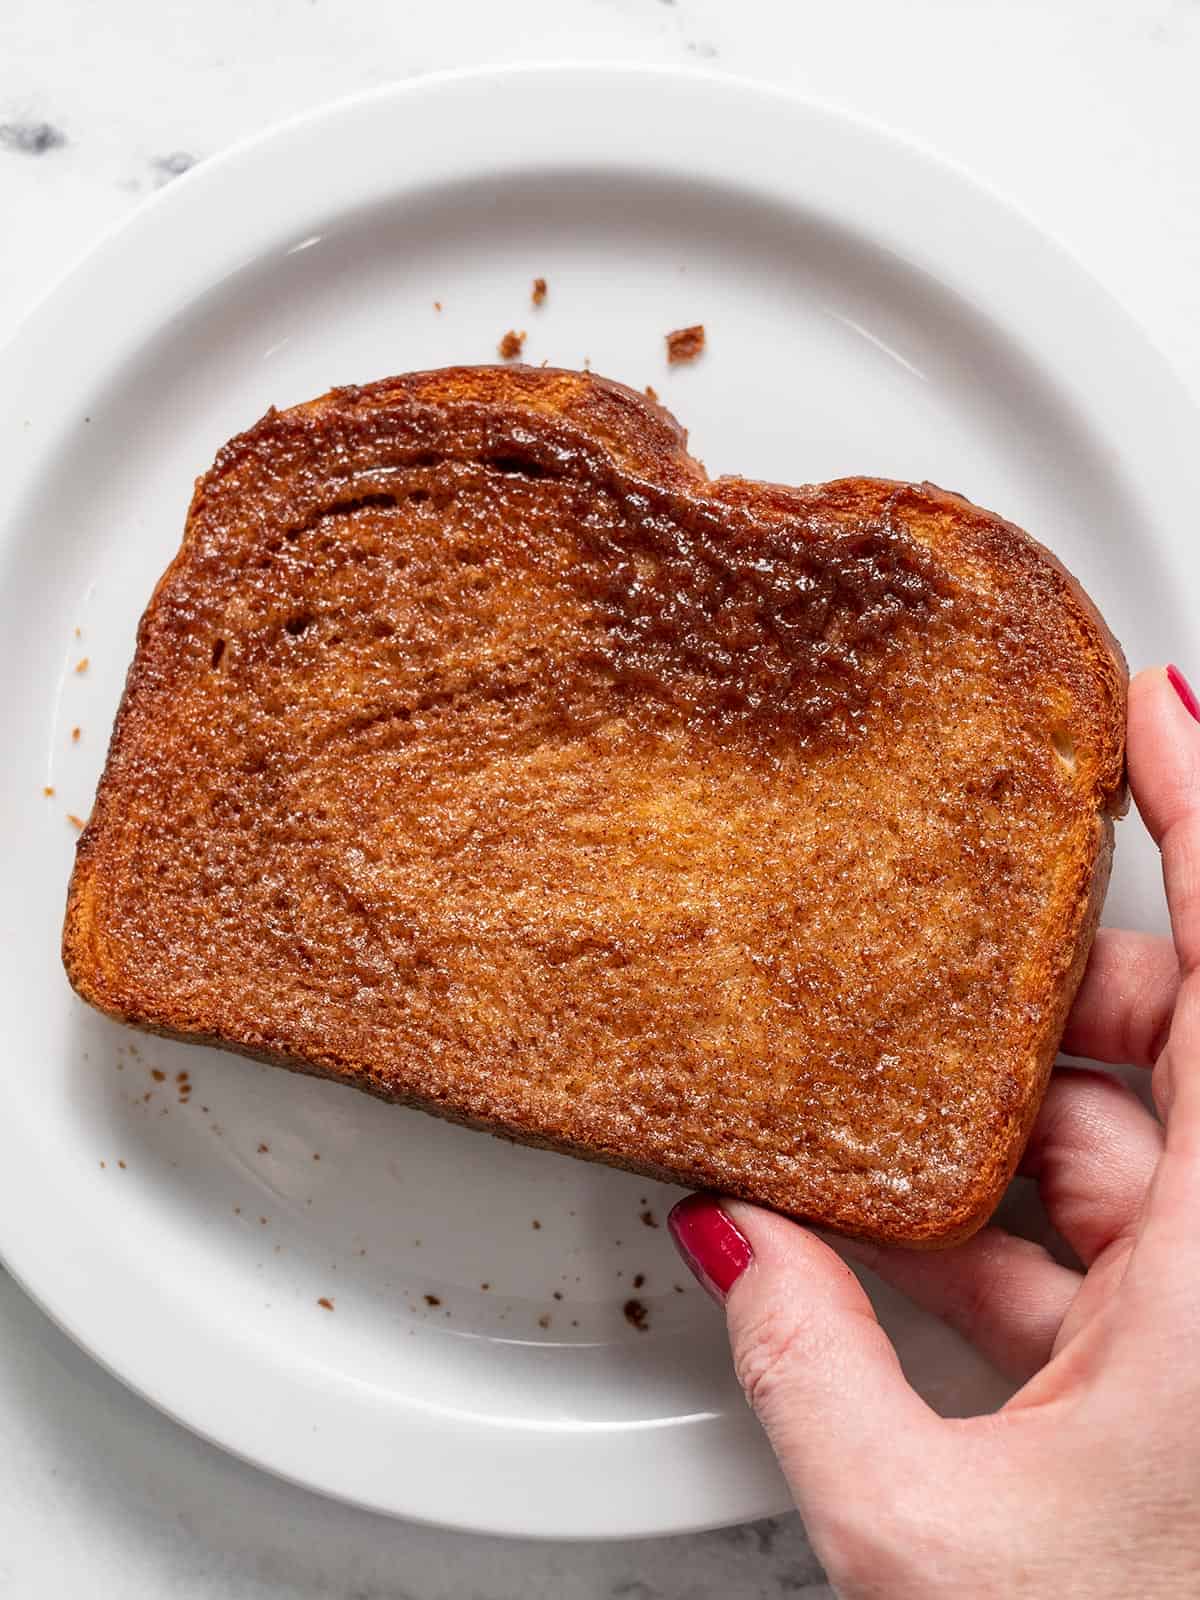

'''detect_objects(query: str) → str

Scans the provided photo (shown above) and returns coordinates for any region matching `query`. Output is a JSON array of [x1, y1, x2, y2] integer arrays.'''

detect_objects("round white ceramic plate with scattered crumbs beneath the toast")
[[0, 67, 1200, 1536]]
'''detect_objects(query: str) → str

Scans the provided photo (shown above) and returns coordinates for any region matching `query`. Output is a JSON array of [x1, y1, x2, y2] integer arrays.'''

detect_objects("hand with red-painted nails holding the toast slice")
[[670, 669, 1200, 1600]]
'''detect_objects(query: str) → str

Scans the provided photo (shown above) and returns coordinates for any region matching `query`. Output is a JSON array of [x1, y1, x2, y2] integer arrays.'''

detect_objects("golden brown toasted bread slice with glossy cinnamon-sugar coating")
[[64, 366, 1125, 1245]]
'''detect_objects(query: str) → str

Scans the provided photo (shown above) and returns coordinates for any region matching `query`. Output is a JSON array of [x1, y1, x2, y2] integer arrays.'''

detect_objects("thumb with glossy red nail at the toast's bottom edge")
[[670, 1194, 947, 1534]]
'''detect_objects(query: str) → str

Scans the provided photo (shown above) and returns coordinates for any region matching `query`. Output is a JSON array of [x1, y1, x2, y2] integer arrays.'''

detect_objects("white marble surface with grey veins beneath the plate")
[[0, 0, 1200, 1600]]
